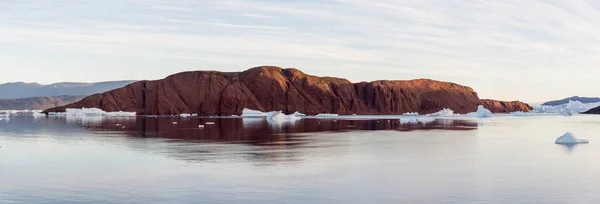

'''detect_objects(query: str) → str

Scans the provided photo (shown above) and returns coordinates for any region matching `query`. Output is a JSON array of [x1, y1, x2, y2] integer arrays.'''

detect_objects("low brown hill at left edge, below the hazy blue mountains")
[[0, 96, 84, 110]]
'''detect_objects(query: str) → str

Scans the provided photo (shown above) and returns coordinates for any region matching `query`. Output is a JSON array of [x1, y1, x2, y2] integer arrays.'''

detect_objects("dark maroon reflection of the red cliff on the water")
[[78, 117, 478, 145]]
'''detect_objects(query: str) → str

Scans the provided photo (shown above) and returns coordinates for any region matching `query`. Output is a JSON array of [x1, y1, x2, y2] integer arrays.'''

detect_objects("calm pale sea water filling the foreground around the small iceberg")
[[0, 116, 600, 203]]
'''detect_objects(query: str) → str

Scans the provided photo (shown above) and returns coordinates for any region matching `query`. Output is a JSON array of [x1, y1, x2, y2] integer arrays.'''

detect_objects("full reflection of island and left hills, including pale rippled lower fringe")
[[0, 116, 477, 165]]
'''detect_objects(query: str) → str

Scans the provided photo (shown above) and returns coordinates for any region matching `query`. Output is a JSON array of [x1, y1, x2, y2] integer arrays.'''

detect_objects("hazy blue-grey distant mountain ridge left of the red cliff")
[[0, 81, 135, 99]]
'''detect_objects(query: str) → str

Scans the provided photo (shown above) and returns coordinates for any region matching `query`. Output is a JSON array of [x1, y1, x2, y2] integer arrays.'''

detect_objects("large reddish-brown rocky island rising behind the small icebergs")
[[45, 67, 524, 116]]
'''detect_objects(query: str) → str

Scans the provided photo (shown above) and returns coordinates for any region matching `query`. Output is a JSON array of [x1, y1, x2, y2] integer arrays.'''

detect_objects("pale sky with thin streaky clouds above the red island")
[[0, 0, 600, 102]]
